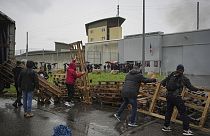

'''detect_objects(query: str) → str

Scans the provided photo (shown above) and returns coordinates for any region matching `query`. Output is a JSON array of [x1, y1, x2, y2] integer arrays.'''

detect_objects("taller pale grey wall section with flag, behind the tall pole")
[[118, 33, 162, 72]]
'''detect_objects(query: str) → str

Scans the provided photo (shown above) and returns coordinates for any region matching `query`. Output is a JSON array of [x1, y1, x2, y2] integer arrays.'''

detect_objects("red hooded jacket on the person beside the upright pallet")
[[66, 63, 83, 85]]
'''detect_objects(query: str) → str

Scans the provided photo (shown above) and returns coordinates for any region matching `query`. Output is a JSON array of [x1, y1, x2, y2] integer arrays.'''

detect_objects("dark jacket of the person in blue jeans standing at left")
[[19, 68, 39, 91]]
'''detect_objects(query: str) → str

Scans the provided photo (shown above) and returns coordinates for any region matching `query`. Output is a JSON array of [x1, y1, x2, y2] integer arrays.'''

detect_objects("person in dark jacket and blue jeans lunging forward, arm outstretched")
[[114, 66, 156, 127]]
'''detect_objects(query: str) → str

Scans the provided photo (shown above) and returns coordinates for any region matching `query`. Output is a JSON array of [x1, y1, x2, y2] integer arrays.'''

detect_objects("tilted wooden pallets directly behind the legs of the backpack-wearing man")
[[138, 83, 210, 131]]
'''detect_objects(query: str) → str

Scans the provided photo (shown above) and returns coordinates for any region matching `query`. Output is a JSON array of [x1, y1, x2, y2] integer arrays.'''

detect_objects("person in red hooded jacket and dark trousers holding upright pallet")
[[65, 60, 85, 106]]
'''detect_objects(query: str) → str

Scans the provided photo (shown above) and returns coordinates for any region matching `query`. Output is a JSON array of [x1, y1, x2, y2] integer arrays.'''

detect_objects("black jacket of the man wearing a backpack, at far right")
[[161, 71, 199, 95]]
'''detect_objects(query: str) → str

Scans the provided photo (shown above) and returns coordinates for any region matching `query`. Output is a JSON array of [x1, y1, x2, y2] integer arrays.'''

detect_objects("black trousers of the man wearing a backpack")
[[164, 94, 189, 130]]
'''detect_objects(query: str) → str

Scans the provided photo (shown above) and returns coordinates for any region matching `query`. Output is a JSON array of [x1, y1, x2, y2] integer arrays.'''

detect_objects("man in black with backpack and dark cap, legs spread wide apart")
[[161, 64, 202, 135]]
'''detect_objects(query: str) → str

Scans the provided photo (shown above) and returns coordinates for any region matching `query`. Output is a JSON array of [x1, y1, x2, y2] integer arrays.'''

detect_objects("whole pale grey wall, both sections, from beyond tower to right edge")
[[119, 29, 210, 75]]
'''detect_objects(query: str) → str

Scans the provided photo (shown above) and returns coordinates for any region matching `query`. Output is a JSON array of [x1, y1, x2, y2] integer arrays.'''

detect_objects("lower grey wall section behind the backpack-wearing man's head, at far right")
[[162, 30, 210, 75]]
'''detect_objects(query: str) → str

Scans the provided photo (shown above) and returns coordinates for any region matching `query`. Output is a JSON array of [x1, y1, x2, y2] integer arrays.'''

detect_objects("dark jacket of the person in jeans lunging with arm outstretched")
[[121, 69, 156, 98]]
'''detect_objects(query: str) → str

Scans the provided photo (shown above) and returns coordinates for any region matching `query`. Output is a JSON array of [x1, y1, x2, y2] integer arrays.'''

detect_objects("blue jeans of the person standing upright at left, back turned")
[[23, 91, 33, 112]]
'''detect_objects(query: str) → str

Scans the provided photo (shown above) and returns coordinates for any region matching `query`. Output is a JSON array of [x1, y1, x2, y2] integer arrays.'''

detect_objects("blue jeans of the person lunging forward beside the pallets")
[[117, 97, 137, 123]]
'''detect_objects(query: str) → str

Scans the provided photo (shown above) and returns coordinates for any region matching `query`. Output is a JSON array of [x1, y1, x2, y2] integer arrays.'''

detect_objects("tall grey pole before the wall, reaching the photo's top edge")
[[142, 0, 145, 74]]
